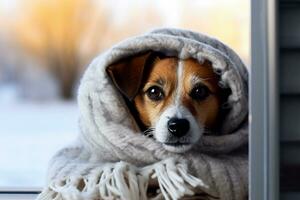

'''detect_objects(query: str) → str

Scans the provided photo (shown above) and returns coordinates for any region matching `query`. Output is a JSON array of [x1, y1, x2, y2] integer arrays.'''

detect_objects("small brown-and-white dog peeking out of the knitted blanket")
[[107, 52, 222, 153]]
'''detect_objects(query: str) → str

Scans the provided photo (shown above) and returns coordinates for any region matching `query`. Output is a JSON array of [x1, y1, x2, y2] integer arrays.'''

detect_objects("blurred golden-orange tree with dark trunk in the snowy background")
[[14, 0, 108, 99]]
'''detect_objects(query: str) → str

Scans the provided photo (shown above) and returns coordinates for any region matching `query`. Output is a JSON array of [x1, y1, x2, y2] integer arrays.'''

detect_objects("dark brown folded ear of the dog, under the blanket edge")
[[106, 52, 151, 100]]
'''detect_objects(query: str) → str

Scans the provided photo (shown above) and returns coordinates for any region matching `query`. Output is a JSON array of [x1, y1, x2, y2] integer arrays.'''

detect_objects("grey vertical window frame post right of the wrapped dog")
[[249, 0, 279, 200]]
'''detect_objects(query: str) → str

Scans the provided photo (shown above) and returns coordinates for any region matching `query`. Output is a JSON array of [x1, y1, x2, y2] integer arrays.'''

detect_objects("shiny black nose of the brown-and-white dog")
[[168, 118, 190, 137]]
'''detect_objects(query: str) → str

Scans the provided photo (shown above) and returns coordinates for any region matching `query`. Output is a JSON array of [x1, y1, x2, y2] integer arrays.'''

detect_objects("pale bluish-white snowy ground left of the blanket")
[[0, 102, 78, 190]]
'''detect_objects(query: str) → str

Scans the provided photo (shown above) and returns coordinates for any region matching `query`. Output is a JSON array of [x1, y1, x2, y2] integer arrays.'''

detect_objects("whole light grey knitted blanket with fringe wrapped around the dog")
[[37, 29, 248, 200]]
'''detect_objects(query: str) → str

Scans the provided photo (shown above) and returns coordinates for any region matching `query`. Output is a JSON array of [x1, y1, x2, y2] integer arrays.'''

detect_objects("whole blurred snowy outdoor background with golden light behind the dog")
[[0, 0, 250, 190]]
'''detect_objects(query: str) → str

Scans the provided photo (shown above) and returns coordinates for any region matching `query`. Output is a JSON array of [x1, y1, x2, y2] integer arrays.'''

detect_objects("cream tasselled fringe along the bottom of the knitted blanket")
[[37, 159, 208, 200]]
